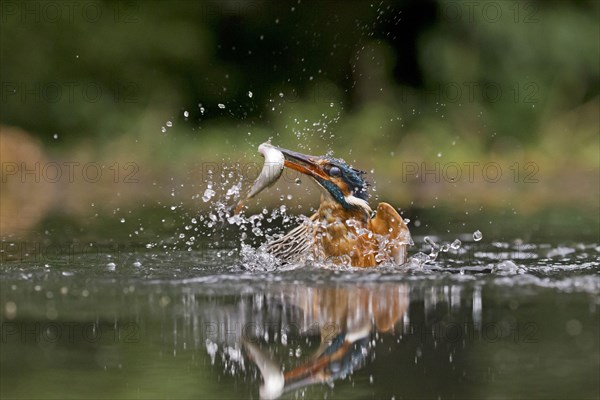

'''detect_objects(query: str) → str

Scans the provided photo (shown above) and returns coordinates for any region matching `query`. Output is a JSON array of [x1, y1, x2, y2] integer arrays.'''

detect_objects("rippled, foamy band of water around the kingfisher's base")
[[2, 238, 600, 294]]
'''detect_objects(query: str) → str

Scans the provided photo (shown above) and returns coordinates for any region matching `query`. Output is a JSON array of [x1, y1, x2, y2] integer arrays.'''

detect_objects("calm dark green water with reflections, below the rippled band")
[[0, 276, 600, 399]]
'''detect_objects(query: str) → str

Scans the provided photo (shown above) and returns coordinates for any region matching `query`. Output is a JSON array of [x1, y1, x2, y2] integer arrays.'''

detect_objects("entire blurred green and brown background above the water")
[[0, 0, 600, 235]]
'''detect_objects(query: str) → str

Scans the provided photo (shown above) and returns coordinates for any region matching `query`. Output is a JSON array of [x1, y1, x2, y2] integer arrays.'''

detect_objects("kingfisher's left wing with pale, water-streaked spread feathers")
[[266, 213, 318, 264]]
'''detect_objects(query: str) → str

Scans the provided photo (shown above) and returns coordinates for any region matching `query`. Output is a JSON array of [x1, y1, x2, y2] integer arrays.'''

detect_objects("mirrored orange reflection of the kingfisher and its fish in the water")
[[202, 284, 409, 399]]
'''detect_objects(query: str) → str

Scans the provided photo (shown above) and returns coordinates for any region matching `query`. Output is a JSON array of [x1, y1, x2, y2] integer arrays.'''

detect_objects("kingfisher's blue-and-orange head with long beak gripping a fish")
[[277, 147, 371, 212]]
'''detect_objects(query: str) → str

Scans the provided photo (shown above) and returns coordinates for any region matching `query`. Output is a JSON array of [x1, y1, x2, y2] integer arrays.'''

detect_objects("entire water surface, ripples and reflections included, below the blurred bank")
[[0, 211, 600, 399]]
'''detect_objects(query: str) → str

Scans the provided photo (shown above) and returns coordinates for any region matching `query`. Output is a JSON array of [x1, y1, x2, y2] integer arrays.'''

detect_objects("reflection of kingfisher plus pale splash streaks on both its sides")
[[178, 283, 481, 399]]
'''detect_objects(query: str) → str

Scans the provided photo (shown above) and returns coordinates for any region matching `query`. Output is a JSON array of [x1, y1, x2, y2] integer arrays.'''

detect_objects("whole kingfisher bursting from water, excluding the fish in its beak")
[[265, 146, 413, 267]]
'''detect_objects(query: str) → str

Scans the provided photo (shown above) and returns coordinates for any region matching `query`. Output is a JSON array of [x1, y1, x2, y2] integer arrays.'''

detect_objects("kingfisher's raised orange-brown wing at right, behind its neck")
[[369, 203, 413, 264]]
